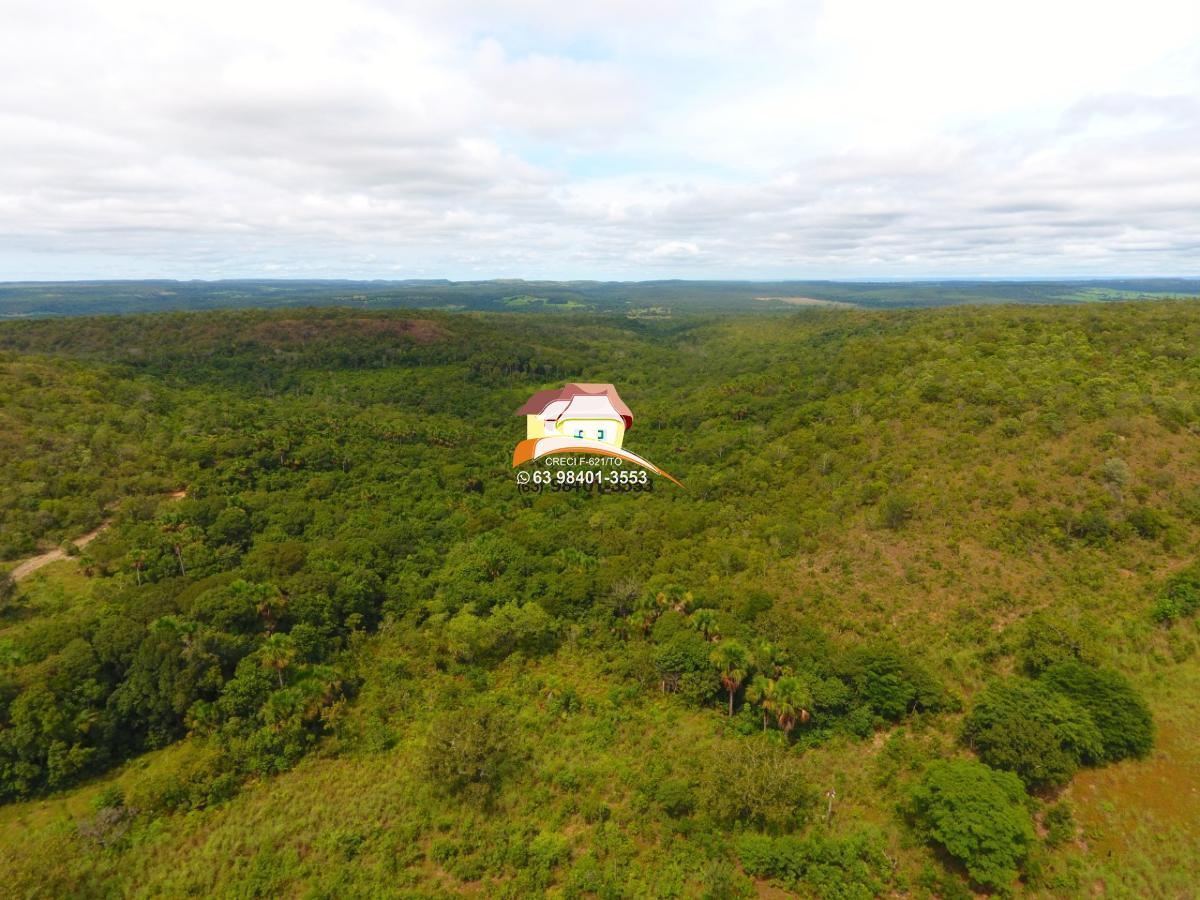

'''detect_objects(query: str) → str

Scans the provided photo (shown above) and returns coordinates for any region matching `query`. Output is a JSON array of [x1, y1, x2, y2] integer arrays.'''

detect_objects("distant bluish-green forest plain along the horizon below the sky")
[[0, 278, 1200, 319]]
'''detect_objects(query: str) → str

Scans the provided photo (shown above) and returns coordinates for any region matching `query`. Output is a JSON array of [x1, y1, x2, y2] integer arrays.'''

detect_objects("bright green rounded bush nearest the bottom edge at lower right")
[[906, 760, 1034, 890]]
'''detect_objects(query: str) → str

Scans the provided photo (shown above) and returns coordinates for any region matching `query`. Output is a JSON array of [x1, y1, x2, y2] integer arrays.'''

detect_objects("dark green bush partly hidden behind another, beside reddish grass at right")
[[1042, 662, 1154, 762]]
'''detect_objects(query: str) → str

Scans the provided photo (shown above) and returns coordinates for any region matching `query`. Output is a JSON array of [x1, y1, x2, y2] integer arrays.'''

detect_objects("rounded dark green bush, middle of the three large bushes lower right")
[[962, 677, 1104, 787]]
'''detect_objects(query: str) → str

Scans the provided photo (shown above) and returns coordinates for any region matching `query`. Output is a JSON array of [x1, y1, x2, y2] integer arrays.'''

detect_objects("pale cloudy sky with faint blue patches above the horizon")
[[0, 0, 1200, 280]]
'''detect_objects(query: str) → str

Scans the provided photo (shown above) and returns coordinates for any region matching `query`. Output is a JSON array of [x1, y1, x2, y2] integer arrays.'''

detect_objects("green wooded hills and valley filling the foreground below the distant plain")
[[0, 303, 1200, 898]]
